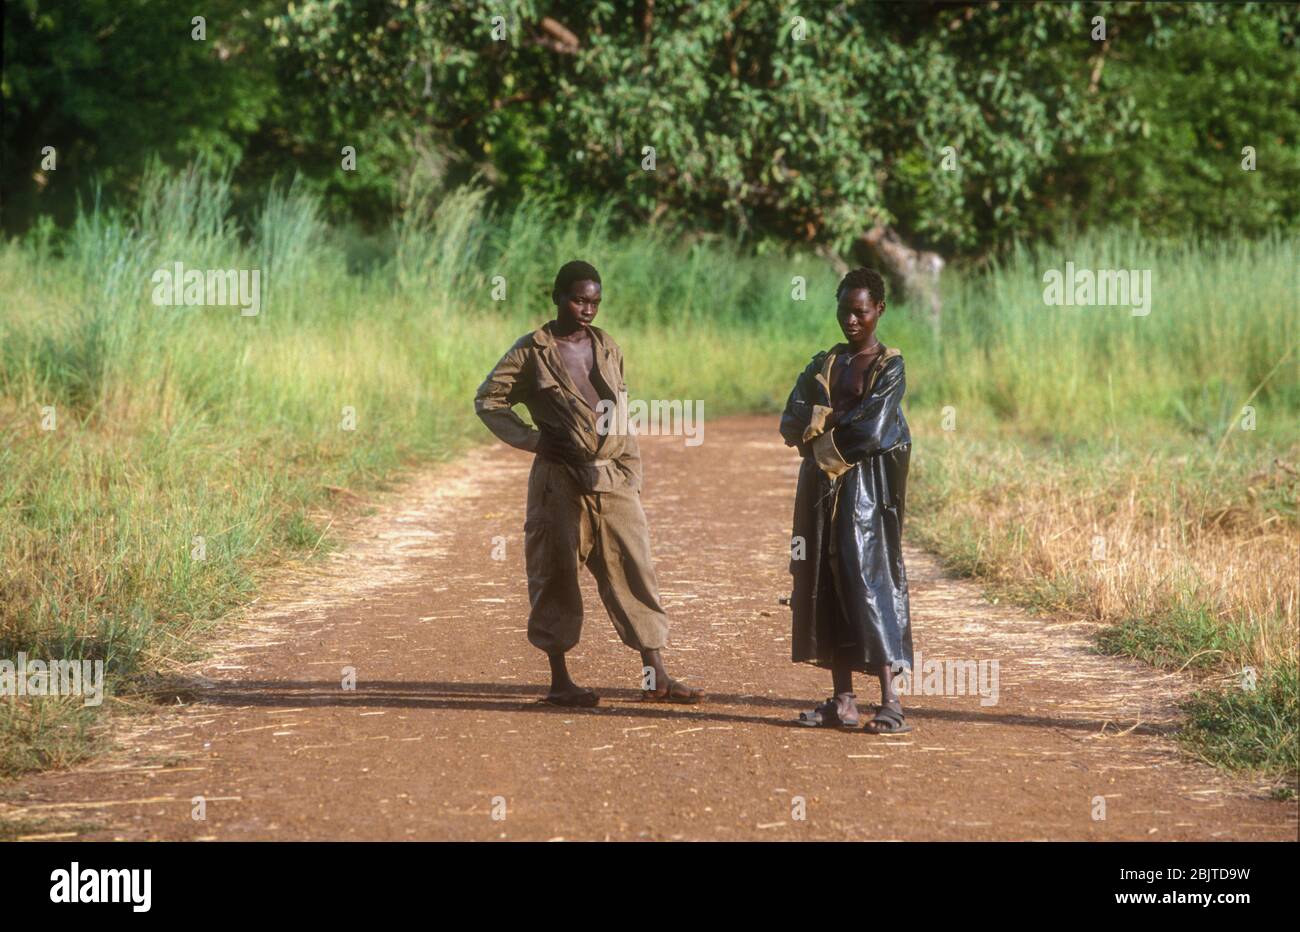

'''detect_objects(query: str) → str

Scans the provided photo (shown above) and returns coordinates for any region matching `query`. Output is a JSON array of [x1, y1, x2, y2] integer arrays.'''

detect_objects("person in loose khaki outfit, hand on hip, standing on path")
[[475, 261, 703, 707]]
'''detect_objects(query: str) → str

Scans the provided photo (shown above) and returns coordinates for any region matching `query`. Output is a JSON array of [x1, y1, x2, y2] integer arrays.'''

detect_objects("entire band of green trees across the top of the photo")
[[4, 0, 1300, 253]]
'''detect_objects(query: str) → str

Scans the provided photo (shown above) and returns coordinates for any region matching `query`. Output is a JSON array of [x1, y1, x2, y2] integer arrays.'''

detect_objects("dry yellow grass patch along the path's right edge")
[[911, 434, 1300, 668]]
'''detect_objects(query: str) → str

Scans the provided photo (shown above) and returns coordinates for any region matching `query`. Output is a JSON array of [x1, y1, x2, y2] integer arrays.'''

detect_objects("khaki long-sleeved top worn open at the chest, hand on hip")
[[475, 321, 641, 491]]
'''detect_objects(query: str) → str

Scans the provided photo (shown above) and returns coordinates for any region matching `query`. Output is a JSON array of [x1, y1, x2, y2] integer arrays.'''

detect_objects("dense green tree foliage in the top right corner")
[[1065, 8, 1300, 237]]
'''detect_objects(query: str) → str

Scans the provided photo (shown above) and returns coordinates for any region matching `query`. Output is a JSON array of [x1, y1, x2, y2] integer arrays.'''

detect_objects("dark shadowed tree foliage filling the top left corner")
[[0, 0, 274, 226]]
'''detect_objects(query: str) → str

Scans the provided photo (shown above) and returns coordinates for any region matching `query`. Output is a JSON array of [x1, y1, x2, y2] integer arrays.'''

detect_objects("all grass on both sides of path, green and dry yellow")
[[0, 165, 1300, 785]]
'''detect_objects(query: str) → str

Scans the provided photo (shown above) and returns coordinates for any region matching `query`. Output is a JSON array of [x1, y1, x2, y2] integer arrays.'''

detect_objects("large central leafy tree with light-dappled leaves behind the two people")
[[263, 0, 1295, 251]]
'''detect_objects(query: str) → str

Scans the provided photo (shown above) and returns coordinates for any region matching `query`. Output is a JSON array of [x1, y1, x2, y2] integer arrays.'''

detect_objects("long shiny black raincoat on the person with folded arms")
[[781, 343, 911, 673]]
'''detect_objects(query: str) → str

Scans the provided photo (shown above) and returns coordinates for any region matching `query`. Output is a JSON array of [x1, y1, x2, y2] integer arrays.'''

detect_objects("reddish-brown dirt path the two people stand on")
[[0, 419, 1296, 841]]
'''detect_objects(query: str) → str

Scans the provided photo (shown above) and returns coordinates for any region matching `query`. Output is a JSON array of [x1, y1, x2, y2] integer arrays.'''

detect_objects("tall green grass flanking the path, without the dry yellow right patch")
[[0, 165, 1300, 770]]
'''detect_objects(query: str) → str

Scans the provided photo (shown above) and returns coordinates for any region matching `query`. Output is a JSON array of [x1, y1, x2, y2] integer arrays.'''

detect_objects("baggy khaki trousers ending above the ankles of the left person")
[[524, 456, 668, 654]]
